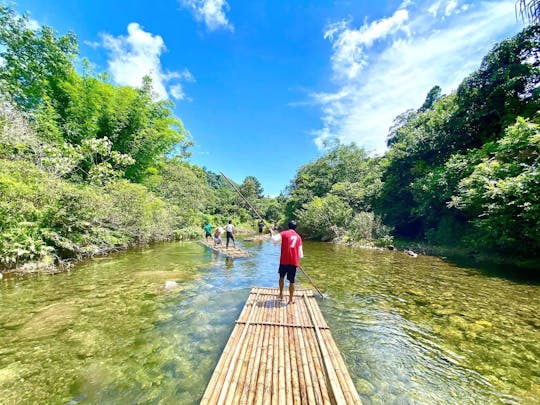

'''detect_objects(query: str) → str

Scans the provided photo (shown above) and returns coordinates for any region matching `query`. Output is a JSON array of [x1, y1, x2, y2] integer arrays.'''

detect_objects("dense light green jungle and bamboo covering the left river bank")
[[0, 6, 279, 268]]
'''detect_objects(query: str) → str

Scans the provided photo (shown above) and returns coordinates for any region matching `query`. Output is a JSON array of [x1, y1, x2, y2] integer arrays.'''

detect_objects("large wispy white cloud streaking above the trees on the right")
[[312, 0, 519, 153]]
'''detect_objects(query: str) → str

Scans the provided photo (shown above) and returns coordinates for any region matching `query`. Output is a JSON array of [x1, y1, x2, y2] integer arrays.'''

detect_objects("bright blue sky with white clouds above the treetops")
[[10, 0, 523, 195]]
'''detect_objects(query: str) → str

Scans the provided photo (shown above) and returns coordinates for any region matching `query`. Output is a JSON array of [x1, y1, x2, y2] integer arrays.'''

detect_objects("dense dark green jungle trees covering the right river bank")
[[286, 25, 540, 257]]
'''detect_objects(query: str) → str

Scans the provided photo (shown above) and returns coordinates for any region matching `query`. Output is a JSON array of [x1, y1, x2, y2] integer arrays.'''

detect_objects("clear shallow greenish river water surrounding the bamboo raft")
[[0, 243, 540, 404]]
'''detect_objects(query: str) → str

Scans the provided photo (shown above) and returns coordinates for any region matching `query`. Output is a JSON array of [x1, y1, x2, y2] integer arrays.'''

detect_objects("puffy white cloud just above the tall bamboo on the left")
[[102, 23, 195, 100]]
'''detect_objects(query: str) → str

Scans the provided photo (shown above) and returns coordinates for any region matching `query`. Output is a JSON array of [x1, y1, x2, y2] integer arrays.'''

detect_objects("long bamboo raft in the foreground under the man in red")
[[201, 288, 361, 404]]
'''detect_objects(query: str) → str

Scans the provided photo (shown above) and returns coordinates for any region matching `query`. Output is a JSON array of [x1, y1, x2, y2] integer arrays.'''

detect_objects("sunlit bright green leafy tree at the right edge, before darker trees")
[[451, 118, 540, 256]]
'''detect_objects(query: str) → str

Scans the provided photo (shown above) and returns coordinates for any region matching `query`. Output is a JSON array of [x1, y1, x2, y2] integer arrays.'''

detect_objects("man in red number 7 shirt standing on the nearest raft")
[[270, 220, 304, 304]]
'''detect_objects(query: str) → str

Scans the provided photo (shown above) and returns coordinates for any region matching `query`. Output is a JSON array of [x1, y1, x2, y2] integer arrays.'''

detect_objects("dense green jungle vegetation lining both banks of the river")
[[0, 6, 540, 269]]
